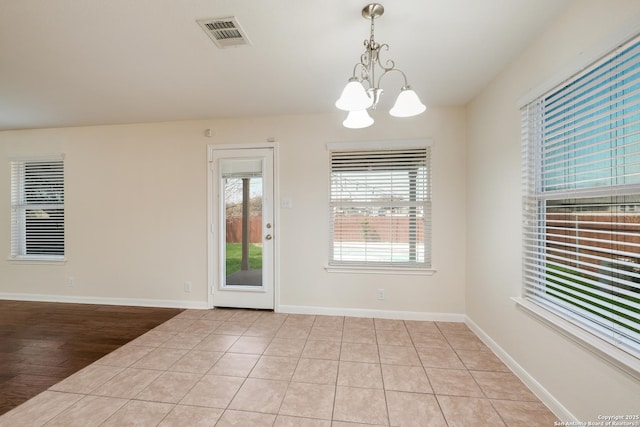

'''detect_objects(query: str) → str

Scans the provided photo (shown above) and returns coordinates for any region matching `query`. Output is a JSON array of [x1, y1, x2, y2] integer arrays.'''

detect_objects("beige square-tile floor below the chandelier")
[[0, 309, 557, 427]]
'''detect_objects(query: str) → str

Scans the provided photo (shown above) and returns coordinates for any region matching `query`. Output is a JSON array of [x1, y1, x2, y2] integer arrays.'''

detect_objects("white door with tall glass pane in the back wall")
[[209, 148, 275, 309]]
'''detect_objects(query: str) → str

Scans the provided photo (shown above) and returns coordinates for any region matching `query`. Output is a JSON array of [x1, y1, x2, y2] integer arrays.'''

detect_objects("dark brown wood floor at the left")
[[0, 300, 182, 415]]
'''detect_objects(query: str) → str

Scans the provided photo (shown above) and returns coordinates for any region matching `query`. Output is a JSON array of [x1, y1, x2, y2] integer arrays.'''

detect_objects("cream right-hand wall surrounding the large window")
[[466, 0, 640, 421]]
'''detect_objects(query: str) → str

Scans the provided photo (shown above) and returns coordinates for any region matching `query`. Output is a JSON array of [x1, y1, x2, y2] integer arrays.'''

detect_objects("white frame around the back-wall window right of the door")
[[325, 139, 435, 275]]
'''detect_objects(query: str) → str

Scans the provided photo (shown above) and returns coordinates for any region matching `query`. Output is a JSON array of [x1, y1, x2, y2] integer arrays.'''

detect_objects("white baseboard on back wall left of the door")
[[0, 292, 207, 309]]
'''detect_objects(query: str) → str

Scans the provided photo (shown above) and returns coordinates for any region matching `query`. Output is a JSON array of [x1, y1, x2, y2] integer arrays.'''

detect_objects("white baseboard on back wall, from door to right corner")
[[276, 305, 466, 323]]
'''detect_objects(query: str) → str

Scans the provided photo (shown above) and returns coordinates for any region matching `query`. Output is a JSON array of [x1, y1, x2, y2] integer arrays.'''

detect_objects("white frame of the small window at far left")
[[9, 155, 67, 263]]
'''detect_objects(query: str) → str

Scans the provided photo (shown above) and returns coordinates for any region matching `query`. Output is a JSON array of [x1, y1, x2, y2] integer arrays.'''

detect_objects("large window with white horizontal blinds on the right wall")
[[522, 39, 640, 358]]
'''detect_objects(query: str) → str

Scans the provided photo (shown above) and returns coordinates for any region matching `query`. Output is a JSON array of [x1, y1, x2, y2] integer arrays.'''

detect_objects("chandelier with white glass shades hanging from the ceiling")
[[336, 3, 427, 129]]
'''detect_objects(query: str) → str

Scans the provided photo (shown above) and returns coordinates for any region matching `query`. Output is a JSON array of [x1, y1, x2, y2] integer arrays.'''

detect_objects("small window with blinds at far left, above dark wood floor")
[[11, 159, 65, 260]]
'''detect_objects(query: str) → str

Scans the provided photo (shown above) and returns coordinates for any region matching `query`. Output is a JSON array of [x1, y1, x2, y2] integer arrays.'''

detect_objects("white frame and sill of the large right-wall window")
[[514, 35, 640, 378]]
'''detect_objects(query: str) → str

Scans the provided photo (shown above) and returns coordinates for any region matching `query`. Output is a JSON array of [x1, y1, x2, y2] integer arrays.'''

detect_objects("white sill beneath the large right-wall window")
[[511, 298, 640, 380]]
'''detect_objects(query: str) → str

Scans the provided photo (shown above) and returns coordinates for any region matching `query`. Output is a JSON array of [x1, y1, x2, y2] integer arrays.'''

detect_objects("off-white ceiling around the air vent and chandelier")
[[0, 0, 567, 130]]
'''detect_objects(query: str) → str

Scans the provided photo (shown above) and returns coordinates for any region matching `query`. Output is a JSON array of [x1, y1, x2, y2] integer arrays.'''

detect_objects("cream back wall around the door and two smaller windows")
[[0, 108, 466, 318]]
